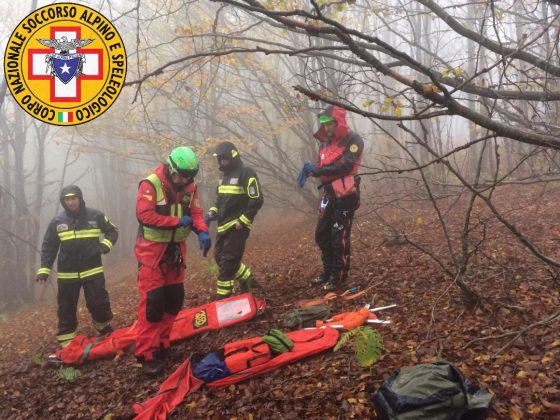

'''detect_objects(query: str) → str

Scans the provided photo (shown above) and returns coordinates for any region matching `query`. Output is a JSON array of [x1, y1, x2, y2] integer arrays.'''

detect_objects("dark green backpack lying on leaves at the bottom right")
[[373, 361, 492, 420]]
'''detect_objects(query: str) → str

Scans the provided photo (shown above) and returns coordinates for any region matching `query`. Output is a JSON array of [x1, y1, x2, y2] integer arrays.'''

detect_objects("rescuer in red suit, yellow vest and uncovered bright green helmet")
[[134, 147, 211, 375]]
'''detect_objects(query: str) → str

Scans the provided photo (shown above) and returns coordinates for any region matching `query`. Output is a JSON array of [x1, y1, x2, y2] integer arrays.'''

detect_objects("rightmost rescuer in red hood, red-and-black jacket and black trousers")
[[298, 106, 364, 291]]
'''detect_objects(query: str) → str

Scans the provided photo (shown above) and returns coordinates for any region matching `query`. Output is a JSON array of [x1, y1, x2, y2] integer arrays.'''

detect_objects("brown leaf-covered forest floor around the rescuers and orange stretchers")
[[0, 191, 560, 419]]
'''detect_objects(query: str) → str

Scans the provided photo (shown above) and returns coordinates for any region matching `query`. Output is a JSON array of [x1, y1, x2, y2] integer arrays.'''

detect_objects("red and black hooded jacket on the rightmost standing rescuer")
[[315, 106, 364, 189]]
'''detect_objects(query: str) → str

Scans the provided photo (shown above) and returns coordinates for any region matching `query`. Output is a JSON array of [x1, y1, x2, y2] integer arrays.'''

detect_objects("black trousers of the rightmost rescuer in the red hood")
[[315, 194, 360, 283]]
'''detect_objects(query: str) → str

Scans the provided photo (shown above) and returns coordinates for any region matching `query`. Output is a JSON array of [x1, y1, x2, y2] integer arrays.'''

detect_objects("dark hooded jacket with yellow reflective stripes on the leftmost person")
[[38, 185, 118, 280]]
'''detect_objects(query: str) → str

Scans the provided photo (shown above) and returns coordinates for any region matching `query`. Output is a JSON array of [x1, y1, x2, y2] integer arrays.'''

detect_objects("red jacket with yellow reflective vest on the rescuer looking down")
[[135, 164, 208, 267]]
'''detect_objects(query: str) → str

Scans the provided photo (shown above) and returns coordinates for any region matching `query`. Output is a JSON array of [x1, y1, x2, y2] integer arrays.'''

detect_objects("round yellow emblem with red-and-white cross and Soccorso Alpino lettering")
[[4, 3, 126, 125]]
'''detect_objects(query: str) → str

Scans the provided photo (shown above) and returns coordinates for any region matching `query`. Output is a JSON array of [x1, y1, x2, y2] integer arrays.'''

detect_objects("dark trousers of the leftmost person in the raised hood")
[[57, 275, 113, 335]]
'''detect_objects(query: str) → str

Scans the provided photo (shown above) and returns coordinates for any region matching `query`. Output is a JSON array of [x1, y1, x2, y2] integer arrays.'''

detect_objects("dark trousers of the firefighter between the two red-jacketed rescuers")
[[214, 227, 251, 297]]
